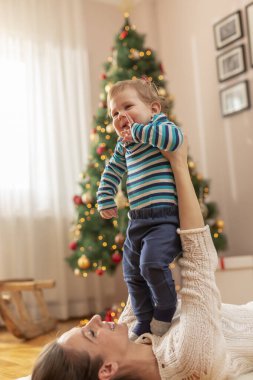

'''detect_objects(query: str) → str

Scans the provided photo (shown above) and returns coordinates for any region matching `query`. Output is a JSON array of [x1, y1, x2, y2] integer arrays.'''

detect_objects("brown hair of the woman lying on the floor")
[[31, 341, 141, 380]]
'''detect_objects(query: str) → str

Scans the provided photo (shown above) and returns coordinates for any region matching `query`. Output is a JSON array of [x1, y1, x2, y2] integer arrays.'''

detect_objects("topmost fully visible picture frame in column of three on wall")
[[213, 10, 243, 50]]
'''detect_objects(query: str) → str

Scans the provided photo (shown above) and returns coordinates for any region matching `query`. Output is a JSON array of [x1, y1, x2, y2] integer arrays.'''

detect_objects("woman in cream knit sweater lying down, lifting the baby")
[[32, 137, 253, 380]]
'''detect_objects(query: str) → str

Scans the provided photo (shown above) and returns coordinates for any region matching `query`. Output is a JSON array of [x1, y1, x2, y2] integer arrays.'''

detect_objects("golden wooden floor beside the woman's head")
[[0, 319, 80, 380]]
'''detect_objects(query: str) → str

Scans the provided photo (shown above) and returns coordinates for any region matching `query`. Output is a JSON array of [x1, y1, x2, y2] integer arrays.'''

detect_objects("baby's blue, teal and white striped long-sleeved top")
[[97, 113, 183, 211]]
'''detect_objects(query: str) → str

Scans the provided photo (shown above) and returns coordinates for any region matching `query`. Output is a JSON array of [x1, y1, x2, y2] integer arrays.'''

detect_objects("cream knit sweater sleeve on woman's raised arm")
[[170, 226, 226, 380]]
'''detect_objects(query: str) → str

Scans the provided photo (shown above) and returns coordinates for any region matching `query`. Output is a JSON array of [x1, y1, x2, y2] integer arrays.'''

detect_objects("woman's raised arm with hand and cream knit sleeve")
[[163, 136, 226, 379]]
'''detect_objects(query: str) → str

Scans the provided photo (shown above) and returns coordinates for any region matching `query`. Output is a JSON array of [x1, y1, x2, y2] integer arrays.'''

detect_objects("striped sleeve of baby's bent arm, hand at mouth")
[[131, 113, 183, 151]]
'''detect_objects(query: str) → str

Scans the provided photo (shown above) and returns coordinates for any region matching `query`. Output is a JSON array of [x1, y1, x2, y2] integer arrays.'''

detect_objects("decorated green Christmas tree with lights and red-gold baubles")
[[67, 14, 226, 277]]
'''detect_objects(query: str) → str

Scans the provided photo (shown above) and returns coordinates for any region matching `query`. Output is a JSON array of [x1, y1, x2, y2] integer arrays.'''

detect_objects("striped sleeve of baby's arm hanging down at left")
[[97, 142, 126, 211]]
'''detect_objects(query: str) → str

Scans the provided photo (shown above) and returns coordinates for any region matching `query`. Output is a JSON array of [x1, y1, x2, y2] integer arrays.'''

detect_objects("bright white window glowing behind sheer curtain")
[[0, 60, 29, 192]]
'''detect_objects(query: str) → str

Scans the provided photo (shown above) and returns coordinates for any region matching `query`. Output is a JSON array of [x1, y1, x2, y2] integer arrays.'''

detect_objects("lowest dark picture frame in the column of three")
[[220, 80, 250, 117]]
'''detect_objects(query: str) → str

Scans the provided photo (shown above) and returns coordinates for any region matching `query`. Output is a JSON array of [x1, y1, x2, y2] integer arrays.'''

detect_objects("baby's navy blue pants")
[[123, 206, 182, 322]]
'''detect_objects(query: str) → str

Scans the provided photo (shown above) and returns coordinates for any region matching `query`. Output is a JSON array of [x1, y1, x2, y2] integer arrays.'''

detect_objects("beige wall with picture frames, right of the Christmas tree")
[[155, 0, 253, 255]]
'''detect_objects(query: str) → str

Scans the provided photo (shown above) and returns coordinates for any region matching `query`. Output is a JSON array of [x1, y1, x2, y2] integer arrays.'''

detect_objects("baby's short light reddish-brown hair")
[[107, 79, 168, 113]]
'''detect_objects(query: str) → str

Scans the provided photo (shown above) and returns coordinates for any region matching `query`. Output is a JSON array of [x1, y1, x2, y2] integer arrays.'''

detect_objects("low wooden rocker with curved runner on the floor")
[[0, 279, 56, 339]]
